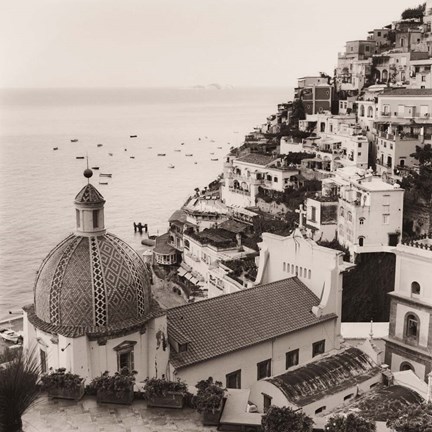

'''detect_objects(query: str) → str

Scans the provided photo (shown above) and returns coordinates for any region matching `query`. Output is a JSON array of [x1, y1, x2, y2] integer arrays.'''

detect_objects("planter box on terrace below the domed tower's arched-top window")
[[89, 367, 137, 405]]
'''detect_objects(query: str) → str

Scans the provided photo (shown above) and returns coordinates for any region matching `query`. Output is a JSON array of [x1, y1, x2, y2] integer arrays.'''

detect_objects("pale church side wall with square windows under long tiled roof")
[[171, 320, 335, 388]]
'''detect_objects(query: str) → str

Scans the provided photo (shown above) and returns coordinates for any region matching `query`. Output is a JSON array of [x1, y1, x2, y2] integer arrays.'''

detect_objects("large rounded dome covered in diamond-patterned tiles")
[[34, 233, 151, 327]]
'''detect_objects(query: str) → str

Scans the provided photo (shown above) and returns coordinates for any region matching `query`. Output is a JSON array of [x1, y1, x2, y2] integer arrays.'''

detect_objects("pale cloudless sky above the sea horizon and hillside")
[[0, 0, 420, 88]]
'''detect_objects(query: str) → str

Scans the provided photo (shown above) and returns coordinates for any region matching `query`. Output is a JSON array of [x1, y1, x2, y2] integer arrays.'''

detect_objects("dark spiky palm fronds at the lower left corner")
[[0, 352, 39, 432]]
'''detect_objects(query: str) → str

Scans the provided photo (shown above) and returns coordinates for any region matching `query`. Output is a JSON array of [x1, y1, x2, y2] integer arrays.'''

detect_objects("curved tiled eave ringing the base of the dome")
[[23, 300, 165, 340]]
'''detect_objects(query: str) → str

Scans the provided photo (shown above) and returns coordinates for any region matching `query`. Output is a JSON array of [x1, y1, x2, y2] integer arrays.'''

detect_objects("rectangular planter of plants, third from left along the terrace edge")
[[144, 375, 187, 408]]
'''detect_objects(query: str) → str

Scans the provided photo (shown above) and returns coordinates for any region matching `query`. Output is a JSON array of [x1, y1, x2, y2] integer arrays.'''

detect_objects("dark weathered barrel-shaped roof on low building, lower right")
[[266, 347, 380, 406]]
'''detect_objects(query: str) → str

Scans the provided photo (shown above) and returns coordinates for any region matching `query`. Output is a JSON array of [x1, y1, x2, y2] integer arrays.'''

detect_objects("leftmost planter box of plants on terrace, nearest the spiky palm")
[[41, 368, 84, 400]]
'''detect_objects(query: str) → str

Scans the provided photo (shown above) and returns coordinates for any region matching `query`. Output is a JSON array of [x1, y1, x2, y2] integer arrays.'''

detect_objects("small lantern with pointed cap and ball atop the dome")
[[75, 169, 106, 236]]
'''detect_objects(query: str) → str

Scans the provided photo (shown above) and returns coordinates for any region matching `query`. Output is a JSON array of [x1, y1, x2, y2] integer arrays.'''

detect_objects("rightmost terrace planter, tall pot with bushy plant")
[[193, 377, 226, 426]]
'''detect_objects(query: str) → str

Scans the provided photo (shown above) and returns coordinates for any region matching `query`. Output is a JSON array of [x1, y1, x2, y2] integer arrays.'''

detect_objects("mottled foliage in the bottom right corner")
[[387, 402, 432, 432]]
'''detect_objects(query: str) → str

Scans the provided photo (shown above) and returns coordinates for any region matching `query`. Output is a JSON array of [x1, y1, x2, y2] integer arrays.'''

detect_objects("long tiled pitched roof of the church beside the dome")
[[167, 278, 336, 368]]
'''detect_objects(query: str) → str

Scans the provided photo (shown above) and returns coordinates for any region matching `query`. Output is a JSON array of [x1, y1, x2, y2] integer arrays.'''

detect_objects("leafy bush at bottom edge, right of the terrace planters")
[[261, 406, 313, 432]]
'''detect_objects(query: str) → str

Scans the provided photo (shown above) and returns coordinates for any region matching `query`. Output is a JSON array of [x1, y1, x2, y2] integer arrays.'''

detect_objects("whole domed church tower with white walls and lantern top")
[[24, 170, 168, 380]]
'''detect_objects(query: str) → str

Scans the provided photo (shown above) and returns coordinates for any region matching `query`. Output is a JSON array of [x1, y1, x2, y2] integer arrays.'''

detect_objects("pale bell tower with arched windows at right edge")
[[385, 236, 432, 381]]
